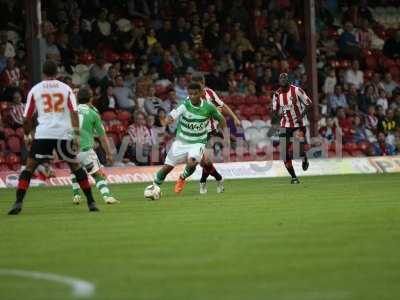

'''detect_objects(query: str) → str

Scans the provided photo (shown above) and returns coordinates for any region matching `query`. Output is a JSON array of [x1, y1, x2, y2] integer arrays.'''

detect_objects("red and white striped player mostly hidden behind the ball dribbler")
[[192, 74, 241, 194]]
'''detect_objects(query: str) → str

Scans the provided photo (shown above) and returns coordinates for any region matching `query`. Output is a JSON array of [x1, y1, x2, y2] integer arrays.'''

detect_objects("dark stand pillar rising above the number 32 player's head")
[[25, 0, 44, 85]]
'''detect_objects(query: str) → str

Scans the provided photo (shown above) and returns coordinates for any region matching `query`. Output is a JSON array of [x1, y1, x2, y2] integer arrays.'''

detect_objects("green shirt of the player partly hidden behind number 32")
[[78, 104, 106, 151]]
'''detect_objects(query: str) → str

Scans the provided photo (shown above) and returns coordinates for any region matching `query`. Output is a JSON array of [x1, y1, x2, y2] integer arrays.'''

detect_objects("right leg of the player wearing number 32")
[[56, 140, 99, 211]]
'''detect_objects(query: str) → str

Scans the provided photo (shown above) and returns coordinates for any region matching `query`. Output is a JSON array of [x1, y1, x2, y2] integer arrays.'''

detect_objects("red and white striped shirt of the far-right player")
[[272, 85, 311, 128]]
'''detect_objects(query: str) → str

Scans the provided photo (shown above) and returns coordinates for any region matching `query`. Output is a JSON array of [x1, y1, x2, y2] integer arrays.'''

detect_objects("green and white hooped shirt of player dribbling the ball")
[[170, 99, 222, 144]]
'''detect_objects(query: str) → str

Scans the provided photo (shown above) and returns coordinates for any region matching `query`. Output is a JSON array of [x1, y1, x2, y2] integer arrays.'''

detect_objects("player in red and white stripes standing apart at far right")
[[272, 73, 311, 184]]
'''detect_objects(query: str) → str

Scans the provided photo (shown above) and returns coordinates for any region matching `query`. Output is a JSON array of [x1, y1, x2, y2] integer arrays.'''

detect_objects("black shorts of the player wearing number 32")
[[29, 139, 77, 162]]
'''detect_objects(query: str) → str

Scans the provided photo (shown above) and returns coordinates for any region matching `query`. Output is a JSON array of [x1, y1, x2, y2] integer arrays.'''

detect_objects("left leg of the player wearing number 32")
[[8, 139, 49, 215]]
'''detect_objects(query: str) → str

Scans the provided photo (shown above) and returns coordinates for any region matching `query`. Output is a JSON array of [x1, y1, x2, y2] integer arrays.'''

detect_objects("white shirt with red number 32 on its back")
[[24, 80, 78, 140]]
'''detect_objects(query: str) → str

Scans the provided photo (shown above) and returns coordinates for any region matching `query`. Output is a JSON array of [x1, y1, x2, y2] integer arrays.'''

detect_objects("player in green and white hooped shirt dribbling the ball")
[[154, 83, 226, 193]]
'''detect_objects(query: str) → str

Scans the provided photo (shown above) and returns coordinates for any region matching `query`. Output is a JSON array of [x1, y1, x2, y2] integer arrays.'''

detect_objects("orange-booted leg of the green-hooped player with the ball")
[[175, 144, 205, 193]]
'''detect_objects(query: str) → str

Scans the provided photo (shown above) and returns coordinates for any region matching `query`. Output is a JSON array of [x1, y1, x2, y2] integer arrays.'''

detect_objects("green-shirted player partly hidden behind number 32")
[[71, 87, 119, 204]]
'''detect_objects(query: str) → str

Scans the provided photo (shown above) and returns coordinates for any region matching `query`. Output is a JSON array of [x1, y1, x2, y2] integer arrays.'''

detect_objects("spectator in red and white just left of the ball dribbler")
[[128, 112, 153, 165]]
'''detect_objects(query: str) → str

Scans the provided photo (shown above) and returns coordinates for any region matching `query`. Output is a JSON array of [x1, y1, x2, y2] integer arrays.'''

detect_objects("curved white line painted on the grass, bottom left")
[[0, 269, 95, 298]]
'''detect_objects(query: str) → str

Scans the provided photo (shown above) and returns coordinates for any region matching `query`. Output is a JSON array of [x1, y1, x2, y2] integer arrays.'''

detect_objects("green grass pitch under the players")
[[0, 174, 400, 300]]
